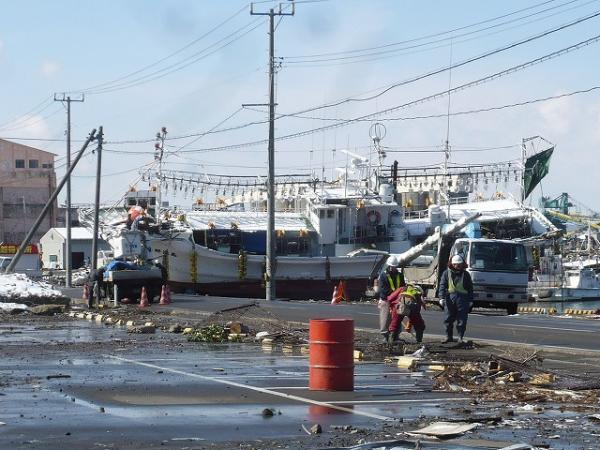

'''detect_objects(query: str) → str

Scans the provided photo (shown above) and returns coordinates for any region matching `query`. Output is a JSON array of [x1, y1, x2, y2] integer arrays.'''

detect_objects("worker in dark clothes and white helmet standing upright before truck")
[[439, 255, 473, 343]]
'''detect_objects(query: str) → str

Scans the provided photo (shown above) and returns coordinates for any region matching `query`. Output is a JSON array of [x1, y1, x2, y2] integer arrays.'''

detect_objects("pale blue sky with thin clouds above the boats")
[[0, 0, 600, 210]]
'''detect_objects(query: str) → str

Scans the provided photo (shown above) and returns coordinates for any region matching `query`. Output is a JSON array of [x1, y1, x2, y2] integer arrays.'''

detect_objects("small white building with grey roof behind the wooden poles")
[[40, 227, 110, 269]]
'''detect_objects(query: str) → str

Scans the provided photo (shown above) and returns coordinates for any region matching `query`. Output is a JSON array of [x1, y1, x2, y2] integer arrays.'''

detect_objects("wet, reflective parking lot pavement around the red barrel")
[[0, 321, 468, 448]]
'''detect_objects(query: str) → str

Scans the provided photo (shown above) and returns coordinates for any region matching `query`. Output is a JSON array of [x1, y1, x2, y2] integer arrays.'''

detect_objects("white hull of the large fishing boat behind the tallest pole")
[[151, 235, 385, 300]]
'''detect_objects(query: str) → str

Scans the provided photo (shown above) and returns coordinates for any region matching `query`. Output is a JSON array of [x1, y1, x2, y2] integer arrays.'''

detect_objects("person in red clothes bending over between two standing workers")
[[387, 284, 425, 343]]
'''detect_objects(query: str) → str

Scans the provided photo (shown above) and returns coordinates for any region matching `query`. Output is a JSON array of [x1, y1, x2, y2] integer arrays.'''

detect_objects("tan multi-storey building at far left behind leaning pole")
[[0, 139, 57, 244]]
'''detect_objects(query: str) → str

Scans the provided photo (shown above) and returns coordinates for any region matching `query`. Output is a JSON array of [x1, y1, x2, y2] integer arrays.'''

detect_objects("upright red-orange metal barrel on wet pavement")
[[308, 319, 354, 391]]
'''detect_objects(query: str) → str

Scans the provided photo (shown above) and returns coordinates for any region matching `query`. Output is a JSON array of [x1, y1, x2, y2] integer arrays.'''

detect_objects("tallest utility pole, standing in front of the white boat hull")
[[250, 2, 295, 300]]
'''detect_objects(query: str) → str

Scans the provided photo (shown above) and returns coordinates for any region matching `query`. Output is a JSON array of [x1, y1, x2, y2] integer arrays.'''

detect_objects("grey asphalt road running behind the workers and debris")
[[166, 295, 600, 353]]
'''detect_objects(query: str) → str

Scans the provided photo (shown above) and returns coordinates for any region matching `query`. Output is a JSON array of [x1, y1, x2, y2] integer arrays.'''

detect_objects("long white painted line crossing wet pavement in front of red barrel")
[[104, 355, 396, 422]]
